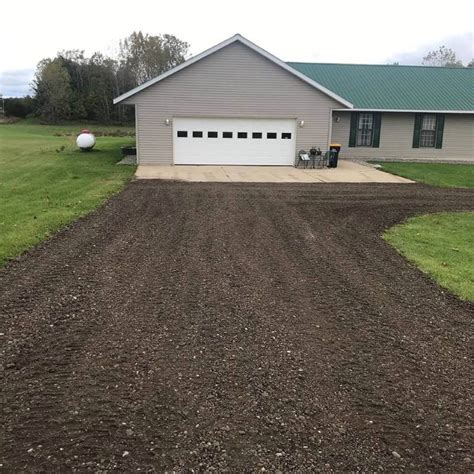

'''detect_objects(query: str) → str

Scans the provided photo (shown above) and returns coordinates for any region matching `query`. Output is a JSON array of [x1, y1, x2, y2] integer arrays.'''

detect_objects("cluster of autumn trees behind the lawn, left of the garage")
[[5, 31, 189, 123]]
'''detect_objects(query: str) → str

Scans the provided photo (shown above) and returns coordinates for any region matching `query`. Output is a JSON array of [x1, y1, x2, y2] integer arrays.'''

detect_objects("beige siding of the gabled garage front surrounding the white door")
[[125, 43, 341, 164]]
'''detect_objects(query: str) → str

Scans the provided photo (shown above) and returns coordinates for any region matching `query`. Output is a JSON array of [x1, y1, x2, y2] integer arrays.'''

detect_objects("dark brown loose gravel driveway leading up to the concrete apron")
[[0, 181, 474, 472]]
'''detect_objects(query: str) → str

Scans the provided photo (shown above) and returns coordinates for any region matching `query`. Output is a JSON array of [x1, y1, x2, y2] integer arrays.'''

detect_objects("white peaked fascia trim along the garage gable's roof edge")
[[114, 34, 353, 109]]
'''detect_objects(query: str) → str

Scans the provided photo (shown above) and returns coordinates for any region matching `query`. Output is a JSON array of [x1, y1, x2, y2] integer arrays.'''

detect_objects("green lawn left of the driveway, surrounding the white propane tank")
[[0, 121, 135, 265]]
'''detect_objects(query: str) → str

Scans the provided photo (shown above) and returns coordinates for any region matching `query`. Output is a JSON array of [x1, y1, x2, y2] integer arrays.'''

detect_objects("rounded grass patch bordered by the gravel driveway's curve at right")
[[384, 212, 474, 301]]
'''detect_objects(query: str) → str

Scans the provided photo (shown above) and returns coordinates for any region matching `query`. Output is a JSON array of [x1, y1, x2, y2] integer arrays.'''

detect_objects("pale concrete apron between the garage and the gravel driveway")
[[135, 160, 413, 183]]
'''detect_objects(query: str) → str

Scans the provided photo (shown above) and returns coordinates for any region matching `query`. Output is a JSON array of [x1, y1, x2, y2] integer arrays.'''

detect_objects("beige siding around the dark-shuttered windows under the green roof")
[[332, 112, 474, 161]]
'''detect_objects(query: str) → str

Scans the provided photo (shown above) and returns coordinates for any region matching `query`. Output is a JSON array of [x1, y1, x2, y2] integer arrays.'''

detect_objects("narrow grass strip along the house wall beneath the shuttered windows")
[[378, 162, 474, 188]]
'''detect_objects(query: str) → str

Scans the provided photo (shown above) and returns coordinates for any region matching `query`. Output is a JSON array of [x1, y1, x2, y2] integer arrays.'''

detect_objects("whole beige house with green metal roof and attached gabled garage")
[[114, 35, 474, 165]]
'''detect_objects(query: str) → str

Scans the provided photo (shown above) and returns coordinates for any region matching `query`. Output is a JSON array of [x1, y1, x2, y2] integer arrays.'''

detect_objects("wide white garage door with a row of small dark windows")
[[173, 118, 296, 165]]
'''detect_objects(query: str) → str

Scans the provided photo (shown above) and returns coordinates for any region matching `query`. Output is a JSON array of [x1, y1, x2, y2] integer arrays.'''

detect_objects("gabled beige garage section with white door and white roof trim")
[[114, 35, 351, 166]]
